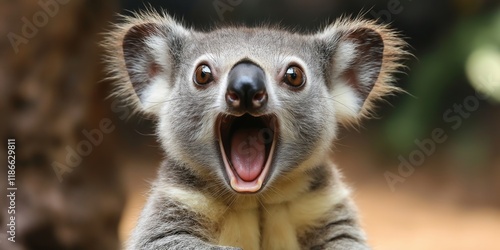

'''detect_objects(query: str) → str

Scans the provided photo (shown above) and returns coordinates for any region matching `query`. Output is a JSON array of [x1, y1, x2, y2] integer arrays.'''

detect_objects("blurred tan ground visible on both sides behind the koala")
[[120, 132, 500, 250]]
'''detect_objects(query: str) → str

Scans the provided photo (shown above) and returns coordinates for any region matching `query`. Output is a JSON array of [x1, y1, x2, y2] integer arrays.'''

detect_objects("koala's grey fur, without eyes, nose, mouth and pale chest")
[[107, 10, 404, 249]]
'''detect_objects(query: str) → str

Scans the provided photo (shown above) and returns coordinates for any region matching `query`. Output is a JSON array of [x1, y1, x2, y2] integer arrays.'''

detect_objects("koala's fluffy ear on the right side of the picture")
[[318, 19, 407, 125]]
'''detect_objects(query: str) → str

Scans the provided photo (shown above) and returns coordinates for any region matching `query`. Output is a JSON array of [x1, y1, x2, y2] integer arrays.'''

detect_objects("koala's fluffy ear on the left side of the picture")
[[104, 14, 190, 115]]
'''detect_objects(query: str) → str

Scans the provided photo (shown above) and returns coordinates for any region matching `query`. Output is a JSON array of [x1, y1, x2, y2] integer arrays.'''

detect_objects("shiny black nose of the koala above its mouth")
[[226, 62, 267, 112]]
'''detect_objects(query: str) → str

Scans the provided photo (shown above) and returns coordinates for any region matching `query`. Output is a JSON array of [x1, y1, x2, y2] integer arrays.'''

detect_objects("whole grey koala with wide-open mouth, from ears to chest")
[[106, 10, 405, 250]]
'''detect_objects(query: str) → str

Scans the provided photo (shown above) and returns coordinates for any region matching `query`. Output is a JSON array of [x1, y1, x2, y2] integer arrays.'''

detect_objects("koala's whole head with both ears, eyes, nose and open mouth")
[[108, 13, 402, 193]]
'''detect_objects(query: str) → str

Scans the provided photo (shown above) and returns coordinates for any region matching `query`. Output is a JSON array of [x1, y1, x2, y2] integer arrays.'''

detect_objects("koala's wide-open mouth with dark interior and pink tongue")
[[218, 114, 278, 193]]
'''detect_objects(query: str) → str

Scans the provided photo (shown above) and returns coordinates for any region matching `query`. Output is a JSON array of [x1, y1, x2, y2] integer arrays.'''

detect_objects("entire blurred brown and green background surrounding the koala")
[[0, 0, 500, 250]]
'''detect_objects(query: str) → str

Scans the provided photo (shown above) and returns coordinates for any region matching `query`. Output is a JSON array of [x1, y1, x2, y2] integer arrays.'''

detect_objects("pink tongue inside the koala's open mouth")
[[231, 128, 266, 181]]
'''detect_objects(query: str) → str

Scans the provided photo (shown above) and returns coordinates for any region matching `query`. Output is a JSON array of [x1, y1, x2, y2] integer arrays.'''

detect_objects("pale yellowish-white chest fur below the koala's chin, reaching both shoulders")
[[161, 166, 349, 250]]
